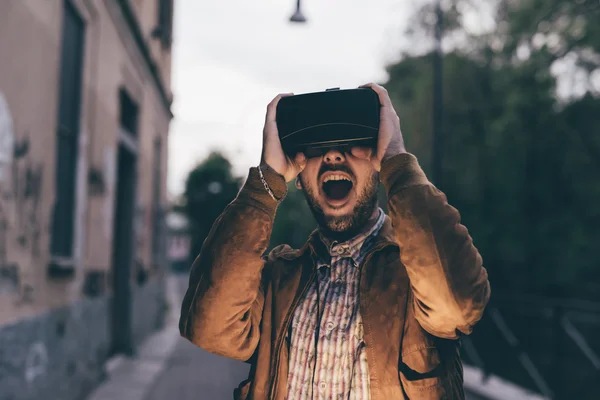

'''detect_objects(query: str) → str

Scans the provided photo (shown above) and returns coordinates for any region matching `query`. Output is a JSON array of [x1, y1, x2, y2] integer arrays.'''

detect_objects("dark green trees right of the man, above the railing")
[[384, 0, 600, 299]]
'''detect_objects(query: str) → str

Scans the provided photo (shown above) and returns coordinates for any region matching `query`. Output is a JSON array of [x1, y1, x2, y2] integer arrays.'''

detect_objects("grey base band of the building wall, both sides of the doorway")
[[0, 279, 165, 400]]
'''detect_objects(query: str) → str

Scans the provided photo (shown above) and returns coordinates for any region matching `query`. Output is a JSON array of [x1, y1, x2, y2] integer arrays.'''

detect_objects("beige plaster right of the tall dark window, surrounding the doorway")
[[85, 2, 170, 290]]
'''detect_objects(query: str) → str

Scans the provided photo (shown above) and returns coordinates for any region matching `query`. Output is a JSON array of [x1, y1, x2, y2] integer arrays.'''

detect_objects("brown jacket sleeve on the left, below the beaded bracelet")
[[179, 162, 287, 361]]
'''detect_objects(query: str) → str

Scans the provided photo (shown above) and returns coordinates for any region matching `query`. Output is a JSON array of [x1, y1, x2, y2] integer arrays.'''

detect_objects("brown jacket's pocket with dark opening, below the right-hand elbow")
[[399, 346, 445, 400]]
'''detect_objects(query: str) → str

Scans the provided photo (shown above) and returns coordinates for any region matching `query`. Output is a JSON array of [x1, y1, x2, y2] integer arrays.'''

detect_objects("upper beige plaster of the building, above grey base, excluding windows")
[[0, 0, 170, 324]]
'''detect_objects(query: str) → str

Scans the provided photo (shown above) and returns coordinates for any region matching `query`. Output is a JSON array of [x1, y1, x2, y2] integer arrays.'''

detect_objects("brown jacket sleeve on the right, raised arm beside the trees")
[[381, 153, 490, 339]]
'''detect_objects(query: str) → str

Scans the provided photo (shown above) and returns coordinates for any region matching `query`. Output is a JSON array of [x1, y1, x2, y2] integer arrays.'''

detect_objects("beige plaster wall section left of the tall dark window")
[[0, 0, 62, 323]]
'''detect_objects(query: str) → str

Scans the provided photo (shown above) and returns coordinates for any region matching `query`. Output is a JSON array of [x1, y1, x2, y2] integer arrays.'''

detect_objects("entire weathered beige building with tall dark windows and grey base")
[[0, 0, 173, 400]]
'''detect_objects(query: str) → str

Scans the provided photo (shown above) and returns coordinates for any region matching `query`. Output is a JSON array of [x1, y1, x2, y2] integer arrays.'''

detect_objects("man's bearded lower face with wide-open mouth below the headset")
[[299, 149, 379, 237]]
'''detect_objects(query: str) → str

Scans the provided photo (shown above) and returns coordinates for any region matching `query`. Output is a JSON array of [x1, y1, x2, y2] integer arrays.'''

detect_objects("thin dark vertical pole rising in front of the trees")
[[431, 0, 444, 188]]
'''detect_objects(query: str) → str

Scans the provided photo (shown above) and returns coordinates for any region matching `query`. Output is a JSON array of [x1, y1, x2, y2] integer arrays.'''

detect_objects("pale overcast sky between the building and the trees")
[[168, 0, 417, 195]]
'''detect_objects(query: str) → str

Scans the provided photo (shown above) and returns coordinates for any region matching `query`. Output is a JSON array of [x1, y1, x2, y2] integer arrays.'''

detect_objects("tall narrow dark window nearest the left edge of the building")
[[50, 0, 85, 266]]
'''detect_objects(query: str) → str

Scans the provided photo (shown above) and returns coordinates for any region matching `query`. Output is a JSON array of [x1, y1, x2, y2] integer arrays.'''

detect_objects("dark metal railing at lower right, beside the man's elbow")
[[462, 294, 600, 399]]
